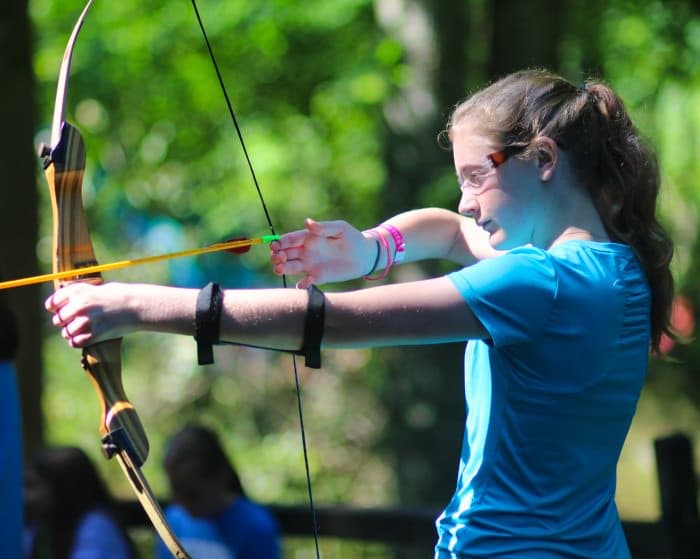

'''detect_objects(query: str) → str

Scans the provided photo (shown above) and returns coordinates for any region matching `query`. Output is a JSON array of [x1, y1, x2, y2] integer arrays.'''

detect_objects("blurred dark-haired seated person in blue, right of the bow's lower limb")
[[156, 424, 280, 559]]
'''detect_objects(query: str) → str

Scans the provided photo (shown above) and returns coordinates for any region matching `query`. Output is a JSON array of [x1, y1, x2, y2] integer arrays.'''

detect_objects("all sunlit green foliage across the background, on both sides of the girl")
[[30, 0, 700, 556]]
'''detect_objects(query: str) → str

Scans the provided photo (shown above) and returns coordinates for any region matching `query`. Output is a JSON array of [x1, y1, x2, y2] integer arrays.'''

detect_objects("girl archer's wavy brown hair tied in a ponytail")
[[441, 70, 675, 352]]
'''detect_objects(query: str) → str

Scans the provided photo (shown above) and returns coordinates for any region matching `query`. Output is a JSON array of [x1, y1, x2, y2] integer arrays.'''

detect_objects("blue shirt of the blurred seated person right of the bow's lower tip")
[[157, 497, 280, 559]]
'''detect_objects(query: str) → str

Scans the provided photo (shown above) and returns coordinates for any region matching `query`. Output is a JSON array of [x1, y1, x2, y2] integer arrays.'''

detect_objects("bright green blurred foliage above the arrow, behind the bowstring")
[[34, 1, 395, 254]]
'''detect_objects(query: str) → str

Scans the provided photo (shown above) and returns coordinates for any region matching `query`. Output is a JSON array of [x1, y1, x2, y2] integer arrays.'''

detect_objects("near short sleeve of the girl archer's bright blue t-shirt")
[[448, 247, 557, 347]]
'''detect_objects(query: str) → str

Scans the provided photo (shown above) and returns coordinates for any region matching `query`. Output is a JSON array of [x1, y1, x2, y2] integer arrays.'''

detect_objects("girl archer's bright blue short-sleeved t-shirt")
[[436, 241, 650, 559]]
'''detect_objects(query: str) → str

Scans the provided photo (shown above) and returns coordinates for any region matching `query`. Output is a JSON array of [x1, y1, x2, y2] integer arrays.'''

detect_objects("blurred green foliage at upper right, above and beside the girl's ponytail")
[[601, 1, 700, 278]]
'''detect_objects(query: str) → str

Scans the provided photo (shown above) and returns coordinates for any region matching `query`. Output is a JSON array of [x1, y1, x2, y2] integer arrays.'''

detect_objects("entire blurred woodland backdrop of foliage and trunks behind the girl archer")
[[0, 0, 700, 557]]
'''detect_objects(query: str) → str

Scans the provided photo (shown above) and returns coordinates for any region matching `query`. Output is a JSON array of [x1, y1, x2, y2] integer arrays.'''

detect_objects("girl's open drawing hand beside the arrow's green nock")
[[270, 218, 377, 288]]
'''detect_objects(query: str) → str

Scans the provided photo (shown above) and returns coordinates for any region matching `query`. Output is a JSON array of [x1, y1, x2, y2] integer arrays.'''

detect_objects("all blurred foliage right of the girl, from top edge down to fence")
[[600, 1, 700, 519]]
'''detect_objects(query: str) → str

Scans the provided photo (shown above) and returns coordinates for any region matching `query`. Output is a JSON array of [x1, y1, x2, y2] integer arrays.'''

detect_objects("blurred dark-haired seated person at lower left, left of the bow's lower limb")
[[25, 447, 137, 559]]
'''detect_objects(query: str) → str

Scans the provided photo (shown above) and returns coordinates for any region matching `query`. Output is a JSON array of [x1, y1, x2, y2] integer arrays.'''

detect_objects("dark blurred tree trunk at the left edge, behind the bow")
[[0, 0, 43, 460]]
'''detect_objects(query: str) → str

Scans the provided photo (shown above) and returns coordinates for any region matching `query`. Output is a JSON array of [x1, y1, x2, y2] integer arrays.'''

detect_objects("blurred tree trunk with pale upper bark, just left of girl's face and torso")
[[372, 6, 476, 540]]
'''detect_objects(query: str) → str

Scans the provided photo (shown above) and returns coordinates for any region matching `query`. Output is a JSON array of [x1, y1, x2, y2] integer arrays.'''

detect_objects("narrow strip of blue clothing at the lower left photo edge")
[[0, 360, 24, 559]]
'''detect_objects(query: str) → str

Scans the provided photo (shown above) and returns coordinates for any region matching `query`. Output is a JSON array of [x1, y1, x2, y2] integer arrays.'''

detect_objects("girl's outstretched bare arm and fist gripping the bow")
[[46, 277, 486, 350]]
